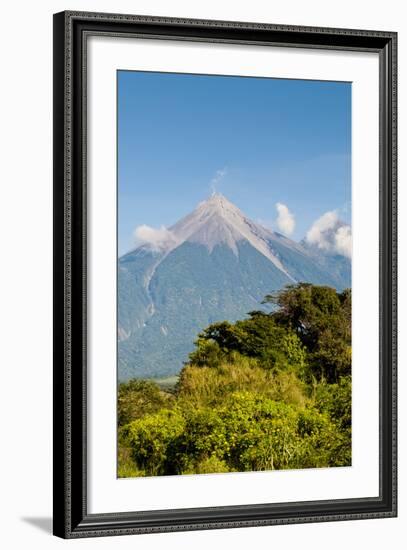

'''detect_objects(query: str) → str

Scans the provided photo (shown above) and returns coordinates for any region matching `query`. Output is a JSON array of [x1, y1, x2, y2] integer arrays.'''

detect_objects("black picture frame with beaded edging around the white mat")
[[53, 11, 397, 538]]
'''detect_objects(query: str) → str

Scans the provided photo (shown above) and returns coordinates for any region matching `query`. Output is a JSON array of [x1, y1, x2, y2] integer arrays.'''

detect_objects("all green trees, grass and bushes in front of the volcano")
[[118, 283, 351, 477]]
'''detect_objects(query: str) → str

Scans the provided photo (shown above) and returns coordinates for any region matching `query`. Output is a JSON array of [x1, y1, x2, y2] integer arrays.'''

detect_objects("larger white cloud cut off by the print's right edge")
[[305, 210, 352, 258]]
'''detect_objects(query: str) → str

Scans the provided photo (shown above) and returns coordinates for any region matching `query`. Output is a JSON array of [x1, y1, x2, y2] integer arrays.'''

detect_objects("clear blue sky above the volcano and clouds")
[[118, 71, 351, 255]]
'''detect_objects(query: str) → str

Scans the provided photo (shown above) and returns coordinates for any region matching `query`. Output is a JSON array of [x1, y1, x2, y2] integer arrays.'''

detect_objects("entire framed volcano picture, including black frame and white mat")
[[53, 12, 397, 538]]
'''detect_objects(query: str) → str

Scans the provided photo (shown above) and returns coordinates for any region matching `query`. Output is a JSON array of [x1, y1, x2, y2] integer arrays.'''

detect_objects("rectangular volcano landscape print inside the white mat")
[[117, 71, 352, 477]]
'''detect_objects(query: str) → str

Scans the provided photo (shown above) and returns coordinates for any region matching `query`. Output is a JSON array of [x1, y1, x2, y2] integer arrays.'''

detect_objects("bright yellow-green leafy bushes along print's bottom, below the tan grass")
[[125, 392, 348, 475]]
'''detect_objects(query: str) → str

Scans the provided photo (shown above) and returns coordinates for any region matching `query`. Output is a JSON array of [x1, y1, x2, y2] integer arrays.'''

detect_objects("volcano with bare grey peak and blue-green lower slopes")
[[118, 195, 348, 380]]
